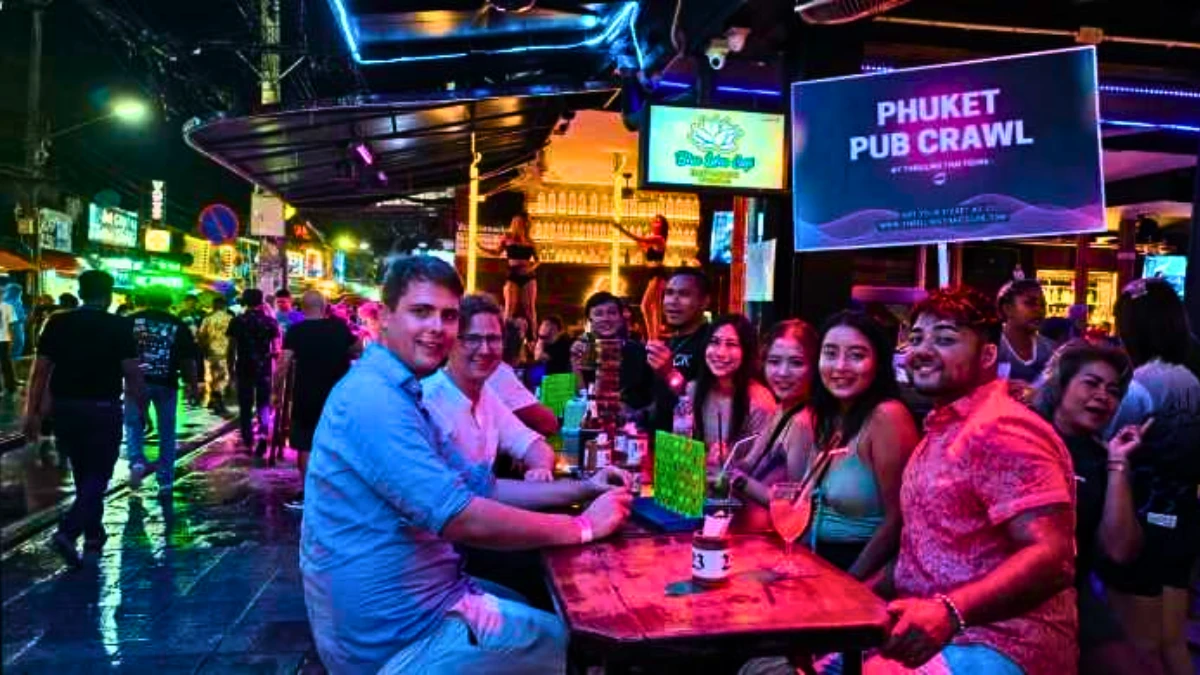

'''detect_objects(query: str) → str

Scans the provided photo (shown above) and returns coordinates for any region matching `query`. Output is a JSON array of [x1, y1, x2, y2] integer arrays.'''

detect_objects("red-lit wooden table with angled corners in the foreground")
[[544, 534, 888, 673]]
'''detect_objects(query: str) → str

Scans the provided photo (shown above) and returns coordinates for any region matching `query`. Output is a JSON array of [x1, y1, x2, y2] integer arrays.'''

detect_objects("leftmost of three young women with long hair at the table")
[[688, 313, 775, 466]]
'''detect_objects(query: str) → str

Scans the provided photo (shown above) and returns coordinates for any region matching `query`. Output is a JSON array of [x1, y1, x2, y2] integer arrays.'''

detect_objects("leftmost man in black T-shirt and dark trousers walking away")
[[24, 270, 145, 567]]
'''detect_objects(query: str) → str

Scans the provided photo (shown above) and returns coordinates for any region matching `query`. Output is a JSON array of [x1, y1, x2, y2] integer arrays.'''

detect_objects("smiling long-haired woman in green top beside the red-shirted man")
[[788, 311, 918, 579]]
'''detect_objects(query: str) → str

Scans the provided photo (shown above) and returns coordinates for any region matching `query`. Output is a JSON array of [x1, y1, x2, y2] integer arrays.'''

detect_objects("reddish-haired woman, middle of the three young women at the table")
[[725, 318, 817, 531]]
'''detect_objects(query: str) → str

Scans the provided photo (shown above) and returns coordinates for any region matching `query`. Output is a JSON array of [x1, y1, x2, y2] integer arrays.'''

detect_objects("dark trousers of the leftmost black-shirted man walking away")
[[54, 399, 121, 540]]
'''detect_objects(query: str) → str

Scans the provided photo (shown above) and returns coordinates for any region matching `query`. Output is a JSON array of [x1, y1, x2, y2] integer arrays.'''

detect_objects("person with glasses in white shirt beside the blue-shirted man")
[[421, 295, 554, 480]]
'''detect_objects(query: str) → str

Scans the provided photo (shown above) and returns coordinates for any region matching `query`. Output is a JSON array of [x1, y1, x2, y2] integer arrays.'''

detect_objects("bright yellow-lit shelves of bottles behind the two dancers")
[[456, 184, 700, 267]]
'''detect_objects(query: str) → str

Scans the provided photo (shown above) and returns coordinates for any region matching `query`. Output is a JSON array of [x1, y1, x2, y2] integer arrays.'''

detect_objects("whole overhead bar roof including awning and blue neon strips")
[[174, 0, 1200, 218]]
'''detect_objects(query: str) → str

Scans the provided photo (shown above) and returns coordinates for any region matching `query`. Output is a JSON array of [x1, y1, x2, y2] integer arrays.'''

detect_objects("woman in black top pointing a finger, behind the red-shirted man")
[[1036, 340, 1146, 674]]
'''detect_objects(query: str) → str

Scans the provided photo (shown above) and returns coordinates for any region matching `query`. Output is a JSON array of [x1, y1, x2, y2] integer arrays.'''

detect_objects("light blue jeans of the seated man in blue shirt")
[[379, 583, 568, 675]]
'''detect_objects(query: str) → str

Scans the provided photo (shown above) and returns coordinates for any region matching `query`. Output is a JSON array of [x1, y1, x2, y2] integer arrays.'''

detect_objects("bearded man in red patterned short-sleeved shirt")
[[865, 283, 1078, 675]]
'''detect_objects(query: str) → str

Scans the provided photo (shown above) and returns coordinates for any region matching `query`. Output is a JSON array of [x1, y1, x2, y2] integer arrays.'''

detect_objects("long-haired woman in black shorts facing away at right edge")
[[1099, 279, 1200, 675]]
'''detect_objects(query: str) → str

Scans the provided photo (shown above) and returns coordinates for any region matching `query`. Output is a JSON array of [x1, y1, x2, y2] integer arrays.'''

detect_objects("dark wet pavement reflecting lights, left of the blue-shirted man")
[[2, 434, 324, 674]]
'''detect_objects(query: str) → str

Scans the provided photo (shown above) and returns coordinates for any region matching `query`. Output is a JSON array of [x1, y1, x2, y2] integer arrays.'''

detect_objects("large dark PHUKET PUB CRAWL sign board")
[[791, 47, 1105, 251]]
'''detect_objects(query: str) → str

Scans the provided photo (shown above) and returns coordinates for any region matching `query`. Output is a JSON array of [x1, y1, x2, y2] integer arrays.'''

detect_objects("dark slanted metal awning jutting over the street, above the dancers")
[[184, 88, 583, 208]]
